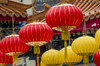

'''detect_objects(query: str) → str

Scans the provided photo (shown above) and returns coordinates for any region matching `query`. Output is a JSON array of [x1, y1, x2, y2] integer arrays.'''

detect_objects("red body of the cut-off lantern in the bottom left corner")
[[0, 51, 13, 64]]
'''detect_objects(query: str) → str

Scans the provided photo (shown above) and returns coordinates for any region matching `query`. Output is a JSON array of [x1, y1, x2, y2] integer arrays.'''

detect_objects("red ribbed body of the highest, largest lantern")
[[46, 4, 83, 27]]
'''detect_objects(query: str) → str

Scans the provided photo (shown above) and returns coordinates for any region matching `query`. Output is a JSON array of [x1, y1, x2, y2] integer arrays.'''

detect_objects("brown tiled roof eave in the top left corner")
[[0, 0, 32, 18]]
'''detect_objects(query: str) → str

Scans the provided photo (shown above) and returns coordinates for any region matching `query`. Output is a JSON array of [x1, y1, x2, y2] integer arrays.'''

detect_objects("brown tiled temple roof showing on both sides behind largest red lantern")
[[27, 0, 100, 22]]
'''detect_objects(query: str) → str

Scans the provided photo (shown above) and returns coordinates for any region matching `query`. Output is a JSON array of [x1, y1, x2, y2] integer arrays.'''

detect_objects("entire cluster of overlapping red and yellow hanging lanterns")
[[0, 1, 100, 66]]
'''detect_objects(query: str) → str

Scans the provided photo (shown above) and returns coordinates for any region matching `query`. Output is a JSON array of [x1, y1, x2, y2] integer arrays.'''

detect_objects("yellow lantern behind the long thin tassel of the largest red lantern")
[[59, 46, 83, 66]]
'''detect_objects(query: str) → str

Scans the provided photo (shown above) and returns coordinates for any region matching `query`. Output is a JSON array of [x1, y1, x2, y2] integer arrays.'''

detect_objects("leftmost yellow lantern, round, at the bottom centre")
[[41, 49, 60, 66]]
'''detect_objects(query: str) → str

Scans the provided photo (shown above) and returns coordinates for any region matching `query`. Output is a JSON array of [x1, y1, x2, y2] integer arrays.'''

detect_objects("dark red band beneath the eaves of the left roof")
[[0, 15, 27, 21]]
